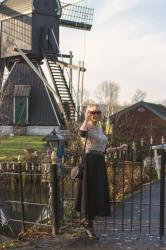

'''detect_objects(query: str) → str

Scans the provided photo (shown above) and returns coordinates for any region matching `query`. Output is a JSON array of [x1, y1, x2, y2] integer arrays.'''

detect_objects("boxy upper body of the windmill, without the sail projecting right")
[[0, 0, 61, 58]]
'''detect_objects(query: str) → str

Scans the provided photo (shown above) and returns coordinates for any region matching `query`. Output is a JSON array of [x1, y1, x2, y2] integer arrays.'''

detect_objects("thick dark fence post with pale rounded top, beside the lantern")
[[51, 151, 59, 235]]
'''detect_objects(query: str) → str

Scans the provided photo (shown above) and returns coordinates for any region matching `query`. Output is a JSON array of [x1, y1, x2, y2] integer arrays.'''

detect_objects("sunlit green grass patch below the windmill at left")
[[0, 136, 45, 161]]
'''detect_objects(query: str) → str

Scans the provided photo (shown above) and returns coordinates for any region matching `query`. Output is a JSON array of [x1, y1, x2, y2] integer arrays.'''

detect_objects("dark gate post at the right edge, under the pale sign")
[[160, 149, 166, 239]]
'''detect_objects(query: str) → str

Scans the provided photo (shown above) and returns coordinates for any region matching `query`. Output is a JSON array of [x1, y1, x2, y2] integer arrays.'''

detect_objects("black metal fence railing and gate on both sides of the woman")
[[0, 146, 166, 237]]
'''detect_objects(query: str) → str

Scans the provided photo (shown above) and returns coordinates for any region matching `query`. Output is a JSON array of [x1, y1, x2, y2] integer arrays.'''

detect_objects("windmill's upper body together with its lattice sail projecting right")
[[0, 0, 93, 58]]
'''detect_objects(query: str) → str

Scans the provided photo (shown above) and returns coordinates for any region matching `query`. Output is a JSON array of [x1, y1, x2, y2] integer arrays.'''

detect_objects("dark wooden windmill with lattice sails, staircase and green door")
[[0, 0, 93, 135]]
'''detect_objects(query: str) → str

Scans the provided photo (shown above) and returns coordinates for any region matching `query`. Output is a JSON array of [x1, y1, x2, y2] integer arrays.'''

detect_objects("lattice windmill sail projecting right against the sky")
[[59, 2, 94, 31]]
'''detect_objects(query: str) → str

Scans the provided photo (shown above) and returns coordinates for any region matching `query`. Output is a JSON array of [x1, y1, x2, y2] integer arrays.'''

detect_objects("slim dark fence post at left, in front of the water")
[[18, 156, 25, 233]]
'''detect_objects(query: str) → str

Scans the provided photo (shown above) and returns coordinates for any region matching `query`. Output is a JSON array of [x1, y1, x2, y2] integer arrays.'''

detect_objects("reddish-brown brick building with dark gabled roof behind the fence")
[[110, 101, 166, 146]]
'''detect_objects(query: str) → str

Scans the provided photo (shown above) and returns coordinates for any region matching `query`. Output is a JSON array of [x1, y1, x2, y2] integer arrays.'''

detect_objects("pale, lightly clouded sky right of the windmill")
[[60, 0, 166, 103]]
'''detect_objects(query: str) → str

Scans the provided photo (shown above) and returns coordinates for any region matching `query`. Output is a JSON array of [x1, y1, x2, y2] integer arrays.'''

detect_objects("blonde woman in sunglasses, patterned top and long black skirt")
[[75, 104, 127, 238]]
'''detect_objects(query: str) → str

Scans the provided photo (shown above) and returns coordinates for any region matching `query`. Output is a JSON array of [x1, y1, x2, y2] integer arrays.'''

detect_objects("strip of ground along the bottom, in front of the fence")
[[7, 232, 166, 250]]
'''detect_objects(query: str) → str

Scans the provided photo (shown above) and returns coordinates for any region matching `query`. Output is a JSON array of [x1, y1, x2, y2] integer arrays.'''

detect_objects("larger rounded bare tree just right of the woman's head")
[[96, 81, 120, 116]]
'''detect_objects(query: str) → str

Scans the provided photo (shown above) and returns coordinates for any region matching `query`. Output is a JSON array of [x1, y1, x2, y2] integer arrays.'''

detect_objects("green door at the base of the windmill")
[[15, 97, 28, 125]]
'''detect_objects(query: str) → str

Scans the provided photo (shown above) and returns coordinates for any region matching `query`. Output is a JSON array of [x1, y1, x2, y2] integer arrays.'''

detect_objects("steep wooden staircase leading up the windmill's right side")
[[45, 55, 76, 121]]
